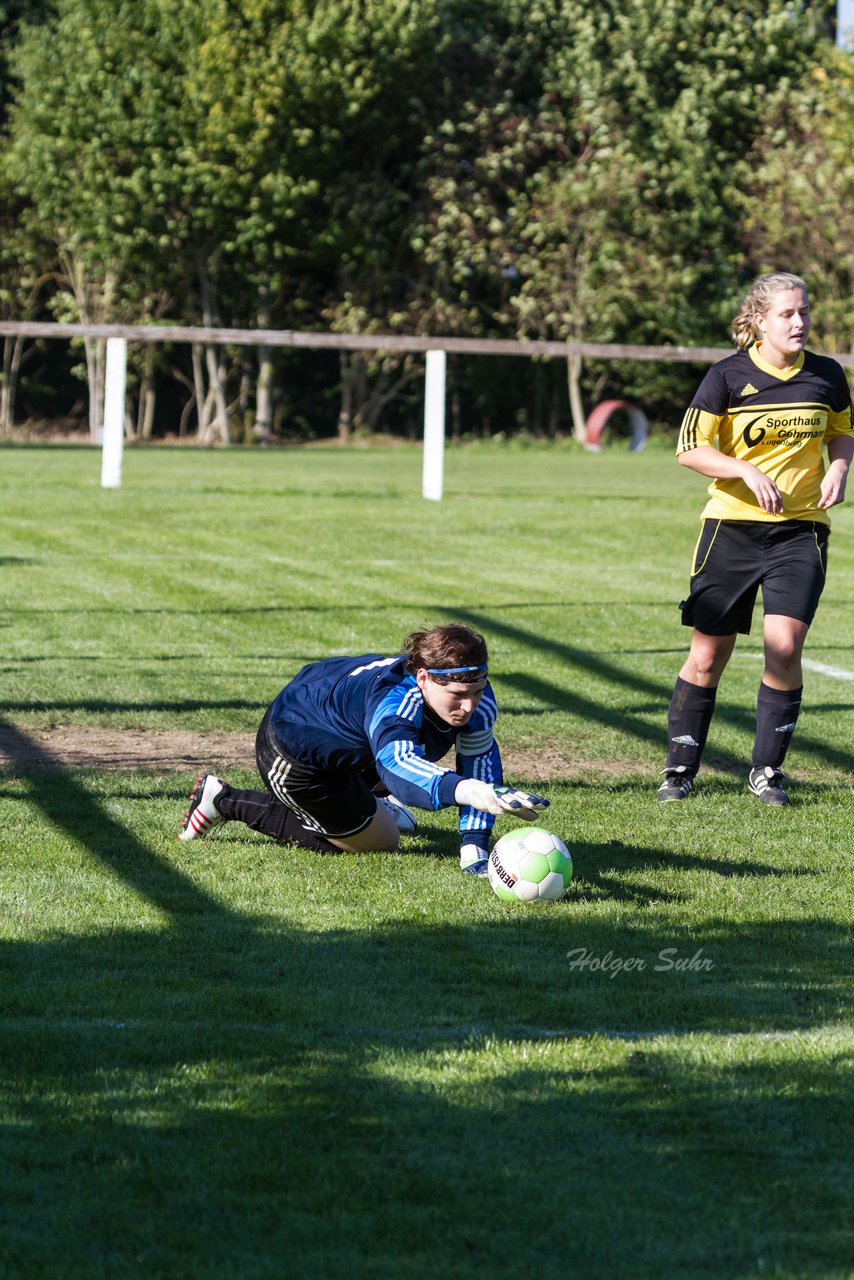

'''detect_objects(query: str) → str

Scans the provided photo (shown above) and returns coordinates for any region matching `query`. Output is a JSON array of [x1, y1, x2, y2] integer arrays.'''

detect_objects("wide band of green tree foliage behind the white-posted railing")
[[0, 0, 851, 431]]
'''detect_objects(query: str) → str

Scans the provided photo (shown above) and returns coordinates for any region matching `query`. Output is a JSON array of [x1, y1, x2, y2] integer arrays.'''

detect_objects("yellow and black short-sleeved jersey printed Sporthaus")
[[676, 347, 854, 525]]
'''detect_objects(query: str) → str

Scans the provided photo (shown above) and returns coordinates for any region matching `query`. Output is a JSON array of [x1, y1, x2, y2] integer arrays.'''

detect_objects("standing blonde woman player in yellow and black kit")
[[658, 273, 854, 805]]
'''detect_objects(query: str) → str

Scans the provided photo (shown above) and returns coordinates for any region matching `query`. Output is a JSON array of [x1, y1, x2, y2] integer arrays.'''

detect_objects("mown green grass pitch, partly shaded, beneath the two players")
[[0, 444, 854, 1280]]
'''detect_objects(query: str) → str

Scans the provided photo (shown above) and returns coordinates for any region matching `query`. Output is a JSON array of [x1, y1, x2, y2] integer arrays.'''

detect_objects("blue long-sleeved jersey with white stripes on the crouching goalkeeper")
[[270, 653, 503, 845]]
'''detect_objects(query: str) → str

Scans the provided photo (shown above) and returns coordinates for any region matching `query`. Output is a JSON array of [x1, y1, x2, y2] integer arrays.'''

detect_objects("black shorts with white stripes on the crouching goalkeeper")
[[255, 709, 378, 840]]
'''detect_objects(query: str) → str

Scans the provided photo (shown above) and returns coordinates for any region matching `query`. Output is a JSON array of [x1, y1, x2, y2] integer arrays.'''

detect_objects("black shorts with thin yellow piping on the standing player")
[[680, 520, 830, 636]]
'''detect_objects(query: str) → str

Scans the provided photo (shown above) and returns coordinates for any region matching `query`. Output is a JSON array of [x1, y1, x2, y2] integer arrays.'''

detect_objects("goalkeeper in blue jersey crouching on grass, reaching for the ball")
[[178, 625, 548, 876]]
